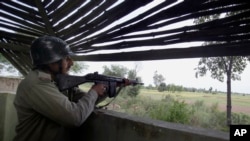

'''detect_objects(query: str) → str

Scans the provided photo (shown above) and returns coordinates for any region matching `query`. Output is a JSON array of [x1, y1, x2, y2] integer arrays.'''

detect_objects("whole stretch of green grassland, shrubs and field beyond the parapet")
[[82, 86, 250, 132]]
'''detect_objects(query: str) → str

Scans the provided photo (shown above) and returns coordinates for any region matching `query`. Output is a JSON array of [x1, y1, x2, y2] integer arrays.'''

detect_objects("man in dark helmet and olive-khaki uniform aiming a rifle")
[[14, 36, 105, 141]]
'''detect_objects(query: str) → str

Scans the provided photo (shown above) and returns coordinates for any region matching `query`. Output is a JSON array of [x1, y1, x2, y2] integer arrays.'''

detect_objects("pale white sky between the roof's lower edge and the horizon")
[[84, 58, 250, 94]]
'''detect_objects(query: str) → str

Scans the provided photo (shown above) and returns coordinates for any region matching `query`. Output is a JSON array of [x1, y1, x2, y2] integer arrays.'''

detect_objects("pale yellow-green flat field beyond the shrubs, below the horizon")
[[139, 89, 250, 115]]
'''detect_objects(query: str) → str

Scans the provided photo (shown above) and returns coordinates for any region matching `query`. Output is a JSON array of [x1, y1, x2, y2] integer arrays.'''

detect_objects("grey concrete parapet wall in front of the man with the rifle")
[[75, 110, 229, 141]]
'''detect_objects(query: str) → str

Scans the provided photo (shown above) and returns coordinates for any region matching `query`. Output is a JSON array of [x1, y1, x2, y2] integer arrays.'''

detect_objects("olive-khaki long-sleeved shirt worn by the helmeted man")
[[14, 70, 98, 141]]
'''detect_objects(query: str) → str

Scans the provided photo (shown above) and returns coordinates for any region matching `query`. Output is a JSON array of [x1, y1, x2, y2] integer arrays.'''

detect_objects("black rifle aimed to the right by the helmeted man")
[[56, 72, 143, 98]]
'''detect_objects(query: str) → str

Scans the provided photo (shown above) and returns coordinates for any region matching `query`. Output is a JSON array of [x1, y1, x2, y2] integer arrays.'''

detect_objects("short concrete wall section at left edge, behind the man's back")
[[0, 92, 17, 141]]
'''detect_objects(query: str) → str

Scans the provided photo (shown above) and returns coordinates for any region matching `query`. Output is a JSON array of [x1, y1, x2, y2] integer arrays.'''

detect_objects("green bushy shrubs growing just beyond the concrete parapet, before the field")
[[110, 95, 250, 132]]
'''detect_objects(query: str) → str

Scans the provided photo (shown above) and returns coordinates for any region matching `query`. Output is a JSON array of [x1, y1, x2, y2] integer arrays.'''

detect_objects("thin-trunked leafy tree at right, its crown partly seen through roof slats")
[[194, 13, 250, 125]]
